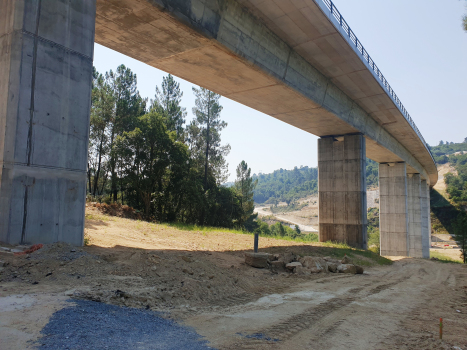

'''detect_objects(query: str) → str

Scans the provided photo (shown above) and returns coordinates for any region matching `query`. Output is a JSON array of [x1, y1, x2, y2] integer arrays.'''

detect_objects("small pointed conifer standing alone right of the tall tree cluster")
[[235, 160, 258, 226]]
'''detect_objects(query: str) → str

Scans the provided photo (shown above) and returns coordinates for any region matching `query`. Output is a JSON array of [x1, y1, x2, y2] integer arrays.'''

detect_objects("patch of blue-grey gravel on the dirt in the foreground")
[[36, 300, 213, 350]]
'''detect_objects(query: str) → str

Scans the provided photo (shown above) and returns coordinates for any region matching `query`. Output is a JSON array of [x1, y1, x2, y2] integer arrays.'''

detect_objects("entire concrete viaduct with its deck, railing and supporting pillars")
[[0, 0, 438, 258]]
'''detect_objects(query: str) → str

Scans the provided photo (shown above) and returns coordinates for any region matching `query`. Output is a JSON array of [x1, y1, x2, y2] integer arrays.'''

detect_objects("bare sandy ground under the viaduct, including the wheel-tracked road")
[[0, 207, 467, 350]]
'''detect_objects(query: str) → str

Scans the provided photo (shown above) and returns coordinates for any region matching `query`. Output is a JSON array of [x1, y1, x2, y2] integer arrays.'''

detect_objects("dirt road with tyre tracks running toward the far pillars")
[[186, 259, 467, 350]]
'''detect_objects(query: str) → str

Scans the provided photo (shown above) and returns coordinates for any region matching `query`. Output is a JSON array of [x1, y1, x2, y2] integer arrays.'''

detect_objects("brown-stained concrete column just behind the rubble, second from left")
[[318, 135, 367, 248]]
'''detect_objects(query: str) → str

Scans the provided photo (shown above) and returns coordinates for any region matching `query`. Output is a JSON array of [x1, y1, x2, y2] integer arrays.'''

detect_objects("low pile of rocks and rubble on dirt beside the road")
[[245, 253, 363, 276]]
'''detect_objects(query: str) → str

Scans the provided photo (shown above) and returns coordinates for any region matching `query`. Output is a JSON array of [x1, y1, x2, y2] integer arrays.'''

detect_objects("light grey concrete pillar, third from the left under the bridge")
[[379, 163, 409, 256]]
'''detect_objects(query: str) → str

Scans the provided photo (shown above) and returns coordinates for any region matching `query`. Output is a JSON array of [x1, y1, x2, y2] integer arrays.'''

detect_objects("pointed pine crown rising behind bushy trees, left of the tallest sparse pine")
[[150, 74, 186, 141]]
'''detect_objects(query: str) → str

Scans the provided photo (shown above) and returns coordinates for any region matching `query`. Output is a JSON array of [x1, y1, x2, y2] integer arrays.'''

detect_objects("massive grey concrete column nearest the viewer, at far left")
[[0, 0, 96, 245]]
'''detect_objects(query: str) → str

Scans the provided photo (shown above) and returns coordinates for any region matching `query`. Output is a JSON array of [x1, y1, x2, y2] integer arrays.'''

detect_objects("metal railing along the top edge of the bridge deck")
[[320, 0, 434, 161]]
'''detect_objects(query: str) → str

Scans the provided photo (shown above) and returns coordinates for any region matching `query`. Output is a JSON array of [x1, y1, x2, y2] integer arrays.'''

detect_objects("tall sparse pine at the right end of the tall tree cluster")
[[189, 87, 230, 191]]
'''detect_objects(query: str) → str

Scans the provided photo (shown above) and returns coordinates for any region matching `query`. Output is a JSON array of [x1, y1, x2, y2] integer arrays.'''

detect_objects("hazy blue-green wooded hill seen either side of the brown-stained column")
[[253, 159, 378, 204]]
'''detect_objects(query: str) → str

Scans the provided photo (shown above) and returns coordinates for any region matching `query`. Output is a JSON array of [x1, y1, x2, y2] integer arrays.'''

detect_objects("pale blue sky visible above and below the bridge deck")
[[94, 0, 467, 181]]
